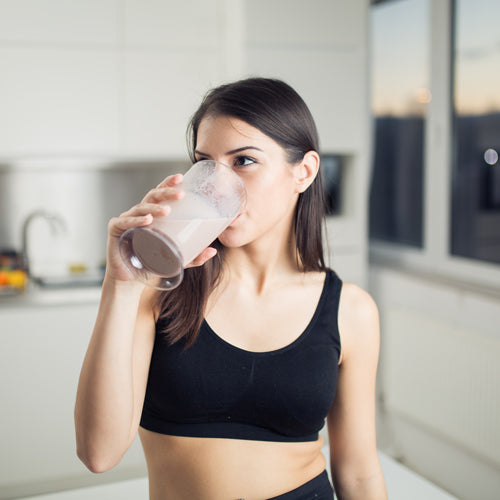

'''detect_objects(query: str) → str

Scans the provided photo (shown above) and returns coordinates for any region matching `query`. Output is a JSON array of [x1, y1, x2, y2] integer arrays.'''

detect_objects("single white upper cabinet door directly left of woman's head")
[[122, 48, 219, 159]]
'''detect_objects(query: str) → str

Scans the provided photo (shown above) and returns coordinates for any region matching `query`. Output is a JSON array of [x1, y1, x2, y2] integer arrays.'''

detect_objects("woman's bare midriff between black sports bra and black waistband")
[[139, 428, 325, 500]]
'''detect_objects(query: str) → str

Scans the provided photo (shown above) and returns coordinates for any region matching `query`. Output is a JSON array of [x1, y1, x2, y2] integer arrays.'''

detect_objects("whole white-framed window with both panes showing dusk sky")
[[370, 0, 500, 293]]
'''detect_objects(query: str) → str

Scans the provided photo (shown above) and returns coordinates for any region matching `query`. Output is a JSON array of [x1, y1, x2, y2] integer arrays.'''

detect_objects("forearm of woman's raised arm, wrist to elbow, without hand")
[[75, 281, 155, 472]]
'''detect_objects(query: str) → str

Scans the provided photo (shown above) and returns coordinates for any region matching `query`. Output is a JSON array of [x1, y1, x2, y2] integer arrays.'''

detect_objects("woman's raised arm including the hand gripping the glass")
[[75, 174, 216, 472]]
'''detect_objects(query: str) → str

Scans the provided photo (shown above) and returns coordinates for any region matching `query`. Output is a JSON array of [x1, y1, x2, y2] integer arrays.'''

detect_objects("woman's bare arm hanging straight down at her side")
[[328, 284, 387, 500]]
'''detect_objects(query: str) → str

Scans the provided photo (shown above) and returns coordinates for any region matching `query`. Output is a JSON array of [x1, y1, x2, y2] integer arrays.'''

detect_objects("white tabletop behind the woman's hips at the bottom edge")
[[20, 453, 457, 500]]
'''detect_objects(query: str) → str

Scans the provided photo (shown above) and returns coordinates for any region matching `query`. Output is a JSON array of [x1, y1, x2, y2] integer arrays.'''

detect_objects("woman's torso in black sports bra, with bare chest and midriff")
[[140, 272, 341, 500]]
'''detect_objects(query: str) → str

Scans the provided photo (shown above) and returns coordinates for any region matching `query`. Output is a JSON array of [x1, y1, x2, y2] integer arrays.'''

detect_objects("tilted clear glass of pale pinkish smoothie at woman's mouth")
[[119, 160, 246, 290]]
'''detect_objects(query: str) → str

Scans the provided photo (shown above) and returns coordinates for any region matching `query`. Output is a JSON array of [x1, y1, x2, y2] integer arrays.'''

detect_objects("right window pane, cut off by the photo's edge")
[[451, 0, 500, 262]]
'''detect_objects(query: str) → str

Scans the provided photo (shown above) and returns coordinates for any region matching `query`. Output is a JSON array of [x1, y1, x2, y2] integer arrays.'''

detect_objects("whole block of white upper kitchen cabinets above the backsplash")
[[0, 0, 229, 159]]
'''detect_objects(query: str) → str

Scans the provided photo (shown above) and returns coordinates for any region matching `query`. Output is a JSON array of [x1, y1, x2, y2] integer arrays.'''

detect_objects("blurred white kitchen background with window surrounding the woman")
[[0, 0, 500, 500]]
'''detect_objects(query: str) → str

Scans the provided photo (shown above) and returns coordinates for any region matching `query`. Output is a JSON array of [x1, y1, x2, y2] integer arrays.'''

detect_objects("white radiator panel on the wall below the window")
[[381, 307, 500, 465]]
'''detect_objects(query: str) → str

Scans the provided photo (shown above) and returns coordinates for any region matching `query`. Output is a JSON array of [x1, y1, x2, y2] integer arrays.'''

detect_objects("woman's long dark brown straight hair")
[[158, 78, 326, 346]]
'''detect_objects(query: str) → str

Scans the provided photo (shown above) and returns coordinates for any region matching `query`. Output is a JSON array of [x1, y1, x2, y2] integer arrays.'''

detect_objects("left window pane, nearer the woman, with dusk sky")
[[369, 0, 430, 247]]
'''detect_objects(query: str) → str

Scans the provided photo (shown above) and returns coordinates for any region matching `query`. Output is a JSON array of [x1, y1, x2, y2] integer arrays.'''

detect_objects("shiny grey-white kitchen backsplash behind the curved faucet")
[[0, 158, 189, 276]]
